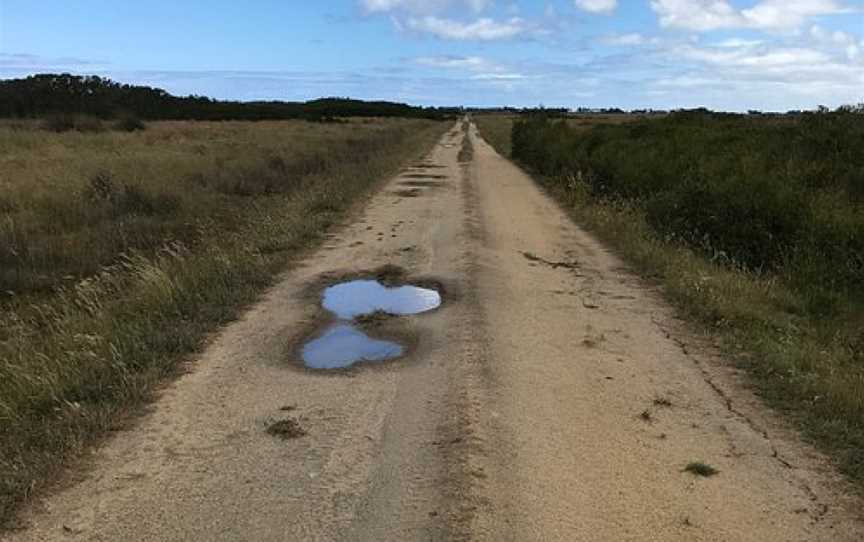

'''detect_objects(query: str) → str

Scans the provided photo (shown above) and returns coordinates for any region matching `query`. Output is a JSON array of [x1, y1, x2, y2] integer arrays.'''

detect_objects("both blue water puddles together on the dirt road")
[[302, 280, 441, 369]]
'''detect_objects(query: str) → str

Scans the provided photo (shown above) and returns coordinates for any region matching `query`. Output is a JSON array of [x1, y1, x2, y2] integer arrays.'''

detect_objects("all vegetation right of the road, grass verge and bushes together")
[[477, 112, 864, 488]]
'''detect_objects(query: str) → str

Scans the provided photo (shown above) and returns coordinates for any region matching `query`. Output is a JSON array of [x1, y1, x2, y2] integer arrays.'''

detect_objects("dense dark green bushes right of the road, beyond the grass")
[[512, 109, 864, 291]]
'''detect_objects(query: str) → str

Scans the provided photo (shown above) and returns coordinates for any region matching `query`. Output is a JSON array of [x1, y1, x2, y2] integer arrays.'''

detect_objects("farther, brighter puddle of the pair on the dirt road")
[[323, 280, 441, 320]]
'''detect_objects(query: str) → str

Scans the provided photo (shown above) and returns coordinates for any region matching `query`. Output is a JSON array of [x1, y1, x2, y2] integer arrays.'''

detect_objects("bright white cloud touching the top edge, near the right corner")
[[651, 0, 849, 32]]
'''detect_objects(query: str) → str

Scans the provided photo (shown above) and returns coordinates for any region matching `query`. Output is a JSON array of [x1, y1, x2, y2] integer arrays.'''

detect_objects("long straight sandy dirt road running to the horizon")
[[8, 126, 864, 541]]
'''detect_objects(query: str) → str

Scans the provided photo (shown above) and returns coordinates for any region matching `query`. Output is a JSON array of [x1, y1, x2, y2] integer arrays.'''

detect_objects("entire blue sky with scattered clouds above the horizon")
[[0, 0, 864, 111]]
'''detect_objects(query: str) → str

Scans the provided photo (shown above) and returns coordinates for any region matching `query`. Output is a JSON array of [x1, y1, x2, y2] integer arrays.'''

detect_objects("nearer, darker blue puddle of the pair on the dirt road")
[[303, 324, 402, 369]]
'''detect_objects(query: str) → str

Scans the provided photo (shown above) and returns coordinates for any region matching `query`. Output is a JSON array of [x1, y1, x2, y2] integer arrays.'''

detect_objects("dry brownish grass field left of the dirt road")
[[0, 119, 449, 525]]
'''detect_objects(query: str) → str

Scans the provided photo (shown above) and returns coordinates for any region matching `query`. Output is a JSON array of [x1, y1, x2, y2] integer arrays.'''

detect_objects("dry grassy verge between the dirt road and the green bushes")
[[476, 116, 864, 490]]
